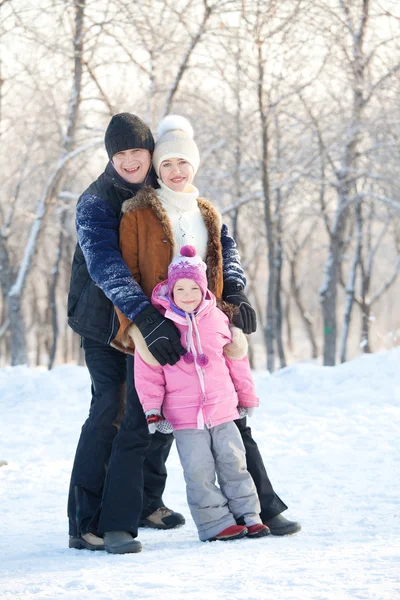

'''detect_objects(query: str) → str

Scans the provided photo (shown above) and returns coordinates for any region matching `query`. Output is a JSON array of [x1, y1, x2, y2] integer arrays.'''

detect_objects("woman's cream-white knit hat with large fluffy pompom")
[[153, 115, 200, 177]]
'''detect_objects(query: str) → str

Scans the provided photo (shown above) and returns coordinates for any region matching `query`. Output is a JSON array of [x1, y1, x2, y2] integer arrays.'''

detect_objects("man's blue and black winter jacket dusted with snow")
[[68, 162, 246, 344]]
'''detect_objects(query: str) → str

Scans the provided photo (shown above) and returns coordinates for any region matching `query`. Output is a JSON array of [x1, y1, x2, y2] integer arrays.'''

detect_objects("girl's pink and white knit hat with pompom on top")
[[168, 246, 208, 298]]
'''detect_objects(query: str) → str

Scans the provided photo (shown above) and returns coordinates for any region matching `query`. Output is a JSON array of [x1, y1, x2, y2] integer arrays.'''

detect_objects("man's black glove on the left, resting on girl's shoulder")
[[135, 306, 186, 366]]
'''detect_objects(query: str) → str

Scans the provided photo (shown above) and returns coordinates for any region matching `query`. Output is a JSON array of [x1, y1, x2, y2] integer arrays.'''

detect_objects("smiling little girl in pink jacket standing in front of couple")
[[132, 246, 269, 541]]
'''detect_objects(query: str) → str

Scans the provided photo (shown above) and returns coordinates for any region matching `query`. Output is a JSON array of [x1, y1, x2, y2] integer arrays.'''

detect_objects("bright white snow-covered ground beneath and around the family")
[[0, 348, 400, 600]]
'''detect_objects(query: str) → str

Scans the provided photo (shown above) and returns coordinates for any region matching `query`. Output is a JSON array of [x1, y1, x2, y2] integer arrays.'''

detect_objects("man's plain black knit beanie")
[[104, 113, 154, 160]]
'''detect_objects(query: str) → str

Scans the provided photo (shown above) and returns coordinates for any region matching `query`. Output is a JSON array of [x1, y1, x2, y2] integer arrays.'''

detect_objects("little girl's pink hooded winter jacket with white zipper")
[[134, 282, 258, 429]]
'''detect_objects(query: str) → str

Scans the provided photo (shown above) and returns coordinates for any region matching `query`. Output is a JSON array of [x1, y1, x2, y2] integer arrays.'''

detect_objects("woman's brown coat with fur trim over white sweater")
[[112, 186, 235, 352]]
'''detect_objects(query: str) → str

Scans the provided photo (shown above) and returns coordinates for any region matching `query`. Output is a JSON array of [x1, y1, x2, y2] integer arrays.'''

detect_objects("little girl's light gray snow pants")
[[174, 422, 261, 541]]
